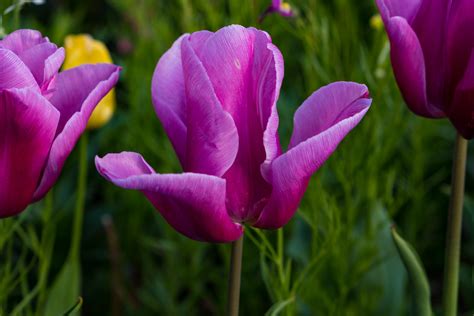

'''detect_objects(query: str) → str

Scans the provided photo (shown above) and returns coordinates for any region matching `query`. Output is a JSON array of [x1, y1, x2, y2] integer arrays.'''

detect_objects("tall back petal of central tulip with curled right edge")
[[196, 25, 283, 222]]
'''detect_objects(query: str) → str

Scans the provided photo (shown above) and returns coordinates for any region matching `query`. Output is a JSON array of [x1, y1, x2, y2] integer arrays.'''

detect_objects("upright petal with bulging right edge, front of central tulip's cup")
[[181, 35, 239, 176]]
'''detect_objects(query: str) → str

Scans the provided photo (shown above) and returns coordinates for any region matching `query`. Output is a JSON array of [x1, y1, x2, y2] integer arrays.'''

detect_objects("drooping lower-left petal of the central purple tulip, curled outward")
[[96, 152, 243, 242]]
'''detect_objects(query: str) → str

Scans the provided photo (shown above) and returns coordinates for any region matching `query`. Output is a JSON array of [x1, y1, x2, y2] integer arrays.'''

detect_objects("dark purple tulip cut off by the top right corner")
[[377, 0, 474, 139]]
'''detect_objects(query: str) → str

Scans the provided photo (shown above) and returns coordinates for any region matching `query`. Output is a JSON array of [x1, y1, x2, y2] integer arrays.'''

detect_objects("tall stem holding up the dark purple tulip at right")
[[443, 134, 467, 316]]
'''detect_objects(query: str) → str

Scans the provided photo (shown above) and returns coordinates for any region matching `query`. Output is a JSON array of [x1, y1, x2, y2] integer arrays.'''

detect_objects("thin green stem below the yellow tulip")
[[69, 132, 87, 260]]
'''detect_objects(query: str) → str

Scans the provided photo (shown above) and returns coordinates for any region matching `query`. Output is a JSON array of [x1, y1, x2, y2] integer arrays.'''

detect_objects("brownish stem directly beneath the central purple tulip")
[[227, 236, 244, 316]]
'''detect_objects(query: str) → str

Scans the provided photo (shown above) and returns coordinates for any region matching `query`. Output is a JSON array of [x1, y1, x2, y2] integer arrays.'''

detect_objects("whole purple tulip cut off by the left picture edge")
[[0, 30, 119, 217]]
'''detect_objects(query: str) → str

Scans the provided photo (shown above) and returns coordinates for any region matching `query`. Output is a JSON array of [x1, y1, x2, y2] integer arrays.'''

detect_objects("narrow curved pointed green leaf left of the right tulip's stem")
[[392, 227, 433, 316]]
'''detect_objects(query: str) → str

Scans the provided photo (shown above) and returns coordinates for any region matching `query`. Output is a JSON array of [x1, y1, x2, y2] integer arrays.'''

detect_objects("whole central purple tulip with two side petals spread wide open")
[[96, 25, 371, 242]]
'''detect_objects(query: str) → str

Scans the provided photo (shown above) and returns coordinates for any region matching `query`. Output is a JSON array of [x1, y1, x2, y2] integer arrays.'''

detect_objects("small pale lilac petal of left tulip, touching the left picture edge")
[[0, 48, 39, 91]]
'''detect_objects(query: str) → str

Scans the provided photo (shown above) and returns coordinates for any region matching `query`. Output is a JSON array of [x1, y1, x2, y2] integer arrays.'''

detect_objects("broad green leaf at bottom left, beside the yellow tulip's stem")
[[44, 257, 81, 315]]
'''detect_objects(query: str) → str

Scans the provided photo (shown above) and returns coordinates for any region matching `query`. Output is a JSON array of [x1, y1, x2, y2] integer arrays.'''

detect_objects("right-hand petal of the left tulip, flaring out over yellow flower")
[[34, 64, 120, 200]]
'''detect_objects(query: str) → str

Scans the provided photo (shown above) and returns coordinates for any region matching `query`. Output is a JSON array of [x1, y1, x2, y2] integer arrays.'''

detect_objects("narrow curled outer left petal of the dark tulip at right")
[[387, 17, 445, 117]]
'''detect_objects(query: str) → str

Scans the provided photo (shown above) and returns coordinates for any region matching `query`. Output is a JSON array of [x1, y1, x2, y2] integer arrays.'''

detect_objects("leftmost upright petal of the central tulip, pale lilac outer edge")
[[151, 35, 188, 166]]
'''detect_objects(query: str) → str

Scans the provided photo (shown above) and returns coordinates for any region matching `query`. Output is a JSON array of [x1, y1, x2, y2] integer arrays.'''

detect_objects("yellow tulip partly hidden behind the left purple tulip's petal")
[[63, 34, 115, 129]]
